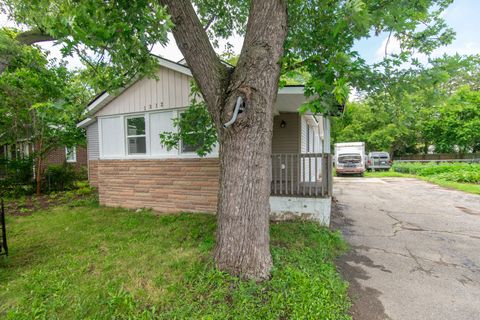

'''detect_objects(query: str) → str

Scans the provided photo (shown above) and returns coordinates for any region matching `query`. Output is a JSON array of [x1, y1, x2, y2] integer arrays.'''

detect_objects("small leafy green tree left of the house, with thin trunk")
[[0, 31, 91, 195]]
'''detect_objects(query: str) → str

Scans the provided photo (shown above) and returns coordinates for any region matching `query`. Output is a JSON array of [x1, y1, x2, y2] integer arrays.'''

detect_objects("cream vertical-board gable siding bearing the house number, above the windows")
[[96, 67, 192, 116]]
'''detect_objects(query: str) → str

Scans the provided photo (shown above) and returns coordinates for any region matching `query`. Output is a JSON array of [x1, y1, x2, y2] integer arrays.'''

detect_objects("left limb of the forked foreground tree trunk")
[[159, 0, 229, 125]]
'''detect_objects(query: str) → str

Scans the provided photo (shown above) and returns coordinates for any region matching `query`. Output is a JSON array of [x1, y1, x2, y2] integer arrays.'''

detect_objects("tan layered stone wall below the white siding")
[[97, 159, 219, 213]]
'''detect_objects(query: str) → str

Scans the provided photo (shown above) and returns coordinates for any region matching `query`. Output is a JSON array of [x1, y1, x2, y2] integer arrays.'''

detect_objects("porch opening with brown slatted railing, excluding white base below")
[[270, 111, 333, 198]]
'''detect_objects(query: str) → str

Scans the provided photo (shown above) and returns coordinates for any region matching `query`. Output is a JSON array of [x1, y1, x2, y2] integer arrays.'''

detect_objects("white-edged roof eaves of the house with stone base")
[[77, 55, 304, 127]]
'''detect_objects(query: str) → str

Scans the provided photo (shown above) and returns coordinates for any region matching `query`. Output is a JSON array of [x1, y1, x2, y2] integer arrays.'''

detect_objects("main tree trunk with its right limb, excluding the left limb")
[[215, 0, 287, 279]]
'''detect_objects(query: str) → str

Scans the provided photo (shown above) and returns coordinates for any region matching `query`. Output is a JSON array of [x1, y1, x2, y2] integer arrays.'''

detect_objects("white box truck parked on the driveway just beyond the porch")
[[335, 142, 365, 176]]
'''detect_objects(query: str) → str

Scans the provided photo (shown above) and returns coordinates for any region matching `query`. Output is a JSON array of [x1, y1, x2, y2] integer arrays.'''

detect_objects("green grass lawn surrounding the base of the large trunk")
[[0, 203, 350, 319]]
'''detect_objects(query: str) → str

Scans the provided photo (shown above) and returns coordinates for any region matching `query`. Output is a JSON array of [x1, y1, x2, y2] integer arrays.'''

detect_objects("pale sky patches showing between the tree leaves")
[[0, 0, 480, 69]]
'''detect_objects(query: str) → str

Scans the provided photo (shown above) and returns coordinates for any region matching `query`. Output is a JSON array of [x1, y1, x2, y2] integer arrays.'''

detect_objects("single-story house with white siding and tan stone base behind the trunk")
[[79, 58, 332, 225]]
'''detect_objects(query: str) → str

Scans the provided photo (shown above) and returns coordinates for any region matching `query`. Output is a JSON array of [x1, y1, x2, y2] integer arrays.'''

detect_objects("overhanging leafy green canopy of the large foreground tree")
[[3, 0, 454, 102]]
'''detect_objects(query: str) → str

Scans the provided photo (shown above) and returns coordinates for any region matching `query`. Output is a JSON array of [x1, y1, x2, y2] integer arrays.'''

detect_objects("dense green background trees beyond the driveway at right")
[[333, 55, 480, 155]]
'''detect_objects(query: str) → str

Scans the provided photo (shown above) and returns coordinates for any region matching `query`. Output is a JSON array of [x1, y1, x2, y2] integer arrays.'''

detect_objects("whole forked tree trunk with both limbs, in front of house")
[[160, 0, 287, 280]]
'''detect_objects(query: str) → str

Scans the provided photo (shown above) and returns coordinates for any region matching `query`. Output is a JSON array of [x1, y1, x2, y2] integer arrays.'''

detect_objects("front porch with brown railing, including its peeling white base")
[[270, 112, 333, 226]]
